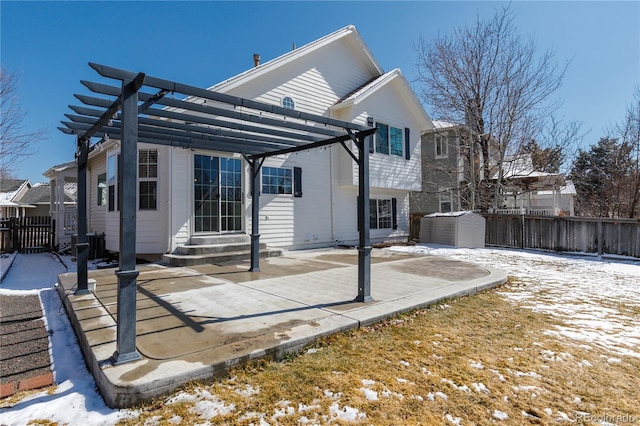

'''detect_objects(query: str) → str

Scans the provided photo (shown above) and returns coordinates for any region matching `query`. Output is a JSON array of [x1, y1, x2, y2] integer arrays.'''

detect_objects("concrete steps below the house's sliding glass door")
[[162, 234, 282, 266]]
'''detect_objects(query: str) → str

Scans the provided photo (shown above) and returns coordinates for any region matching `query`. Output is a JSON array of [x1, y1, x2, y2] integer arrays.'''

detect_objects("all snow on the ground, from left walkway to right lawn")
[[0, 245, 640, 425]]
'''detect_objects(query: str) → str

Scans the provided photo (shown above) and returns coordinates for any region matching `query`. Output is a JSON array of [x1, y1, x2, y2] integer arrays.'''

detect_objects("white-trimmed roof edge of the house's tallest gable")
[[208, 25, 384, 92]]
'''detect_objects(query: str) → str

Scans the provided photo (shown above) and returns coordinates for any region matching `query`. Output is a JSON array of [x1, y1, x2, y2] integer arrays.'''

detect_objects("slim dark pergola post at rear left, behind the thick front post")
[[75, 138, 89, 295]]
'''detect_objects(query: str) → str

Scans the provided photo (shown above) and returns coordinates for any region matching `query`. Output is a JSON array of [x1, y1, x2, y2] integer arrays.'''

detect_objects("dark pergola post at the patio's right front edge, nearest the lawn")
[[355, 134, 373, 302]]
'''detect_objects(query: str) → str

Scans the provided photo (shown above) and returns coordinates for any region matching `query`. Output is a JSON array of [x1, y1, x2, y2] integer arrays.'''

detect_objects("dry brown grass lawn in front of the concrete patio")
[[116, 283, 640, 425]]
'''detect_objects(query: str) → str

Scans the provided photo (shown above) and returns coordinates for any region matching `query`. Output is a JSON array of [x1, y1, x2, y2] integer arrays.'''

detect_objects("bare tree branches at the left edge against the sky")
[[0, 66, 45, 178]]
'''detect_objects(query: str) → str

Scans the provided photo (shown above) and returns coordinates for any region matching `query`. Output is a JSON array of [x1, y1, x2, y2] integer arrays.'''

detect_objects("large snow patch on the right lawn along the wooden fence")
[[389, 245, 640, 362]]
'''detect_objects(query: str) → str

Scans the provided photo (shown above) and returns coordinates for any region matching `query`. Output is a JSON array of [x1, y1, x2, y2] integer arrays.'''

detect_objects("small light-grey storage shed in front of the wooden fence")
[[420, 211, 486, 248]]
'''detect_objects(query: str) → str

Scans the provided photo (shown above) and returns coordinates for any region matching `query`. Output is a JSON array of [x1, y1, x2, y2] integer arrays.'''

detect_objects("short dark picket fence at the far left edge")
[[0, 216, 53, 253]]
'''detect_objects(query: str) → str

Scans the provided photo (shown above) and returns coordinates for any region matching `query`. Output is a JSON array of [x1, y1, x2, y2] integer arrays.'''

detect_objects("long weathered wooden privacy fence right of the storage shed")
[[483, 214, 640, 258]]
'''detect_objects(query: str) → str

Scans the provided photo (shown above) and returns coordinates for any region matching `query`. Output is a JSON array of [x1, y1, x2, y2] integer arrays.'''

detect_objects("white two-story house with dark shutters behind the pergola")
[[79, 26, 433, 253]]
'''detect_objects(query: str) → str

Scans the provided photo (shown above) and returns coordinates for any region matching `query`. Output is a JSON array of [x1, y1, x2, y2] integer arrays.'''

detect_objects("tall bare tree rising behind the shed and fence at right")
[[416, 7, 568, 212]]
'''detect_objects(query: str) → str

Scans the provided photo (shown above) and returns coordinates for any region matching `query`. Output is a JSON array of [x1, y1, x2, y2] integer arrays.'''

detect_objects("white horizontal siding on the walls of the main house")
[[97, 29, 425, 253]]
